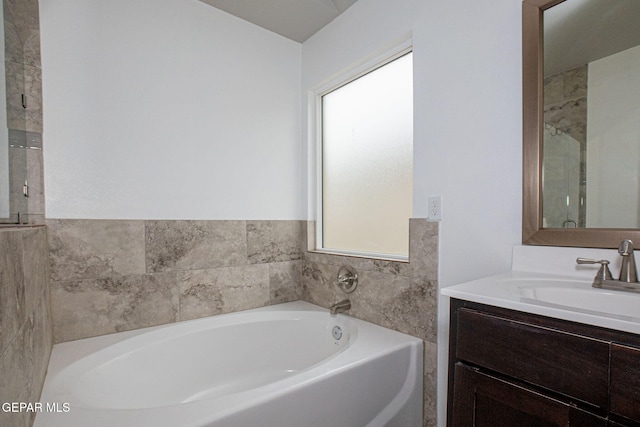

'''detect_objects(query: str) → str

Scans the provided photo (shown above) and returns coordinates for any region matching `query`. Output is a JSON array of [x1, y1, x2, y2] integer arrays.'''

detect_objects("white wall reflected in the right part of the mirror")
[[587, 46, 640, 228]]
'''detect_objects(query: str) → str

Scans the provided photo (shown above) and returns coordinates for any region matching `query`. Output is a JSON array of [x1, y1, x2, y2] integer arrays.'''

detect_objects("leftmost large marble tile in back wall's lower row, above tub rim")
[[51, 273, 178, 342]]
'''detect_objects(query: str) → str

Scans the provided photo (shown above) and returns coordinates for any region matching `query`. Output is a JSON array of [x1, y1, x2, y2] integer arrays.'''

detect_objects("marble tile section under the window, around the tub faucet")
[[302, 219, 438, 426]]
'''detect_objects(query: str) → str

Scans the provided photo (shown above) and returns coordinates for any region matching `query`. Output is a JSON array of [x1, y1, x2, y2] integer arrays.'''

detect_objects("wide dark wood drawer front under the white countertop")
[[456, 309, 609, 408]]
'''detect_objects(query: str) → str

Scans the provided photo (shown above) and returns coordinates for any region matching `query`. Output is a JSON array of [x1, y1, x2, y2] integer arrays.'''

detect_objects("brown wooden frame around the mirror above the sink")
[[522, 0, 640, 248]]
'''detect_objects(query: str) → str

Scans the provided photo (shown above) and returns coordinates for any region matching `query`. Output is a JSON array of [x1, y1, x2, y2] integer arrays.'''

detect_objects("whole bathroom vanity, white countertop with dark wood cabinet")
[[441, 246, 640, 427]]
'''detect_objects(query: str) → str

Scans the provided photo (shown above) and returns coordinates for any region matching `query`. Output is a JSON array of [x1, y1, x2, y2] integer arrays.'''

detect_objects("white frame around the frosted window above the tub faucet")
[[307, 35, 415, 262]]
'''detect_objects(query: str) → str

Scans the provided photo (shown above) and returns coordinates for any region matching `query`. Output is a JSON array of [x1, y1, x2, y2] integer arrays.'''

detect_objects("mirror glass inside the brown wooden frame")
[[544, 0, 640, 229]]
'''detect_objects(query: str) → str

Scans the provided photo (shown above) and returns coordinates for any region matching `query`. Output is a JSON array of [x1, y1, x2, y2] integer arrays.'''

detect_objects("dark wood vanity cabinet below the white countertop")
[[447, 299, 640, 427]]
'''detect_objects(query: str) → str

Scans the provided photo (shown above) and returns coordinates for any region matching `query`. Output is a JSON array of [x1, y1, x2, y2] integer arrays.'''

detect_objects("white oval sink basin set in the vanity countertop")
[[497, 278, 640, 318]]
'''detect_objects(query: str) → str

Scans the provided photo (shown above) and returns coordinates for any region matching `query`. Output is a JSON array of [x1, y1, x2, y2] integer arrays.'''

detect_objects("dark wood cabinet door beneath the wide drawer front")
[[449, 363, 607, 427]]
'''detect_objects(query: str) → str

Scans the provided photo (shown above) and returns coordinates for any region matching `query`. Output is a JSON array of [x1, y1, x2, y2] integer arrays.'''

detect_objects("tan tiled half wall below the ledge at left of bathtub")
[[0, 227, 52, 427]]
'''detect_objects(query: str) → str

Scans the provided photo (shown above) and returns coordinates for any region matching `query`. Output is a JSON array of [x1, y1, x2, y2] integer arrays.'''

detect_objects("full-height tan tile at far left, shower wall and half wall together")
[[0, 0, 53, 427]]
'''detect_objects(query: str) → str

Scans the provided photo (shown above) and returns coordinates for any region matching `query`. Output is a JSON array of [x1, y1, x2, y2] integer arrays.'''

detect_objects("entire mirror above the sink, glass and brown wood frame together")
[[522, 0, 640, 248]]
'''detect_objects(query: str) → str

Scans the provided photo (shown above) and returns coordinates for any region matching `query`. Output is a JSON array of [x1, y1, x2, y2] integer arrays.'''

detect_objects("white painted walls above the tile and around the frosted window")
[[40, 0, 522, 422]]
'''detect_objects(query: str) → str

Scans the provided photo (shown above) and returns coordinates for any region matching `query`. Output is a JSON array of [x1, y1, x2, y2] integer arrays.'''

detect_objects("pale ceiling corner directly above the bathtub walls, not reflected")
[[200, 0, 357, 43]]
